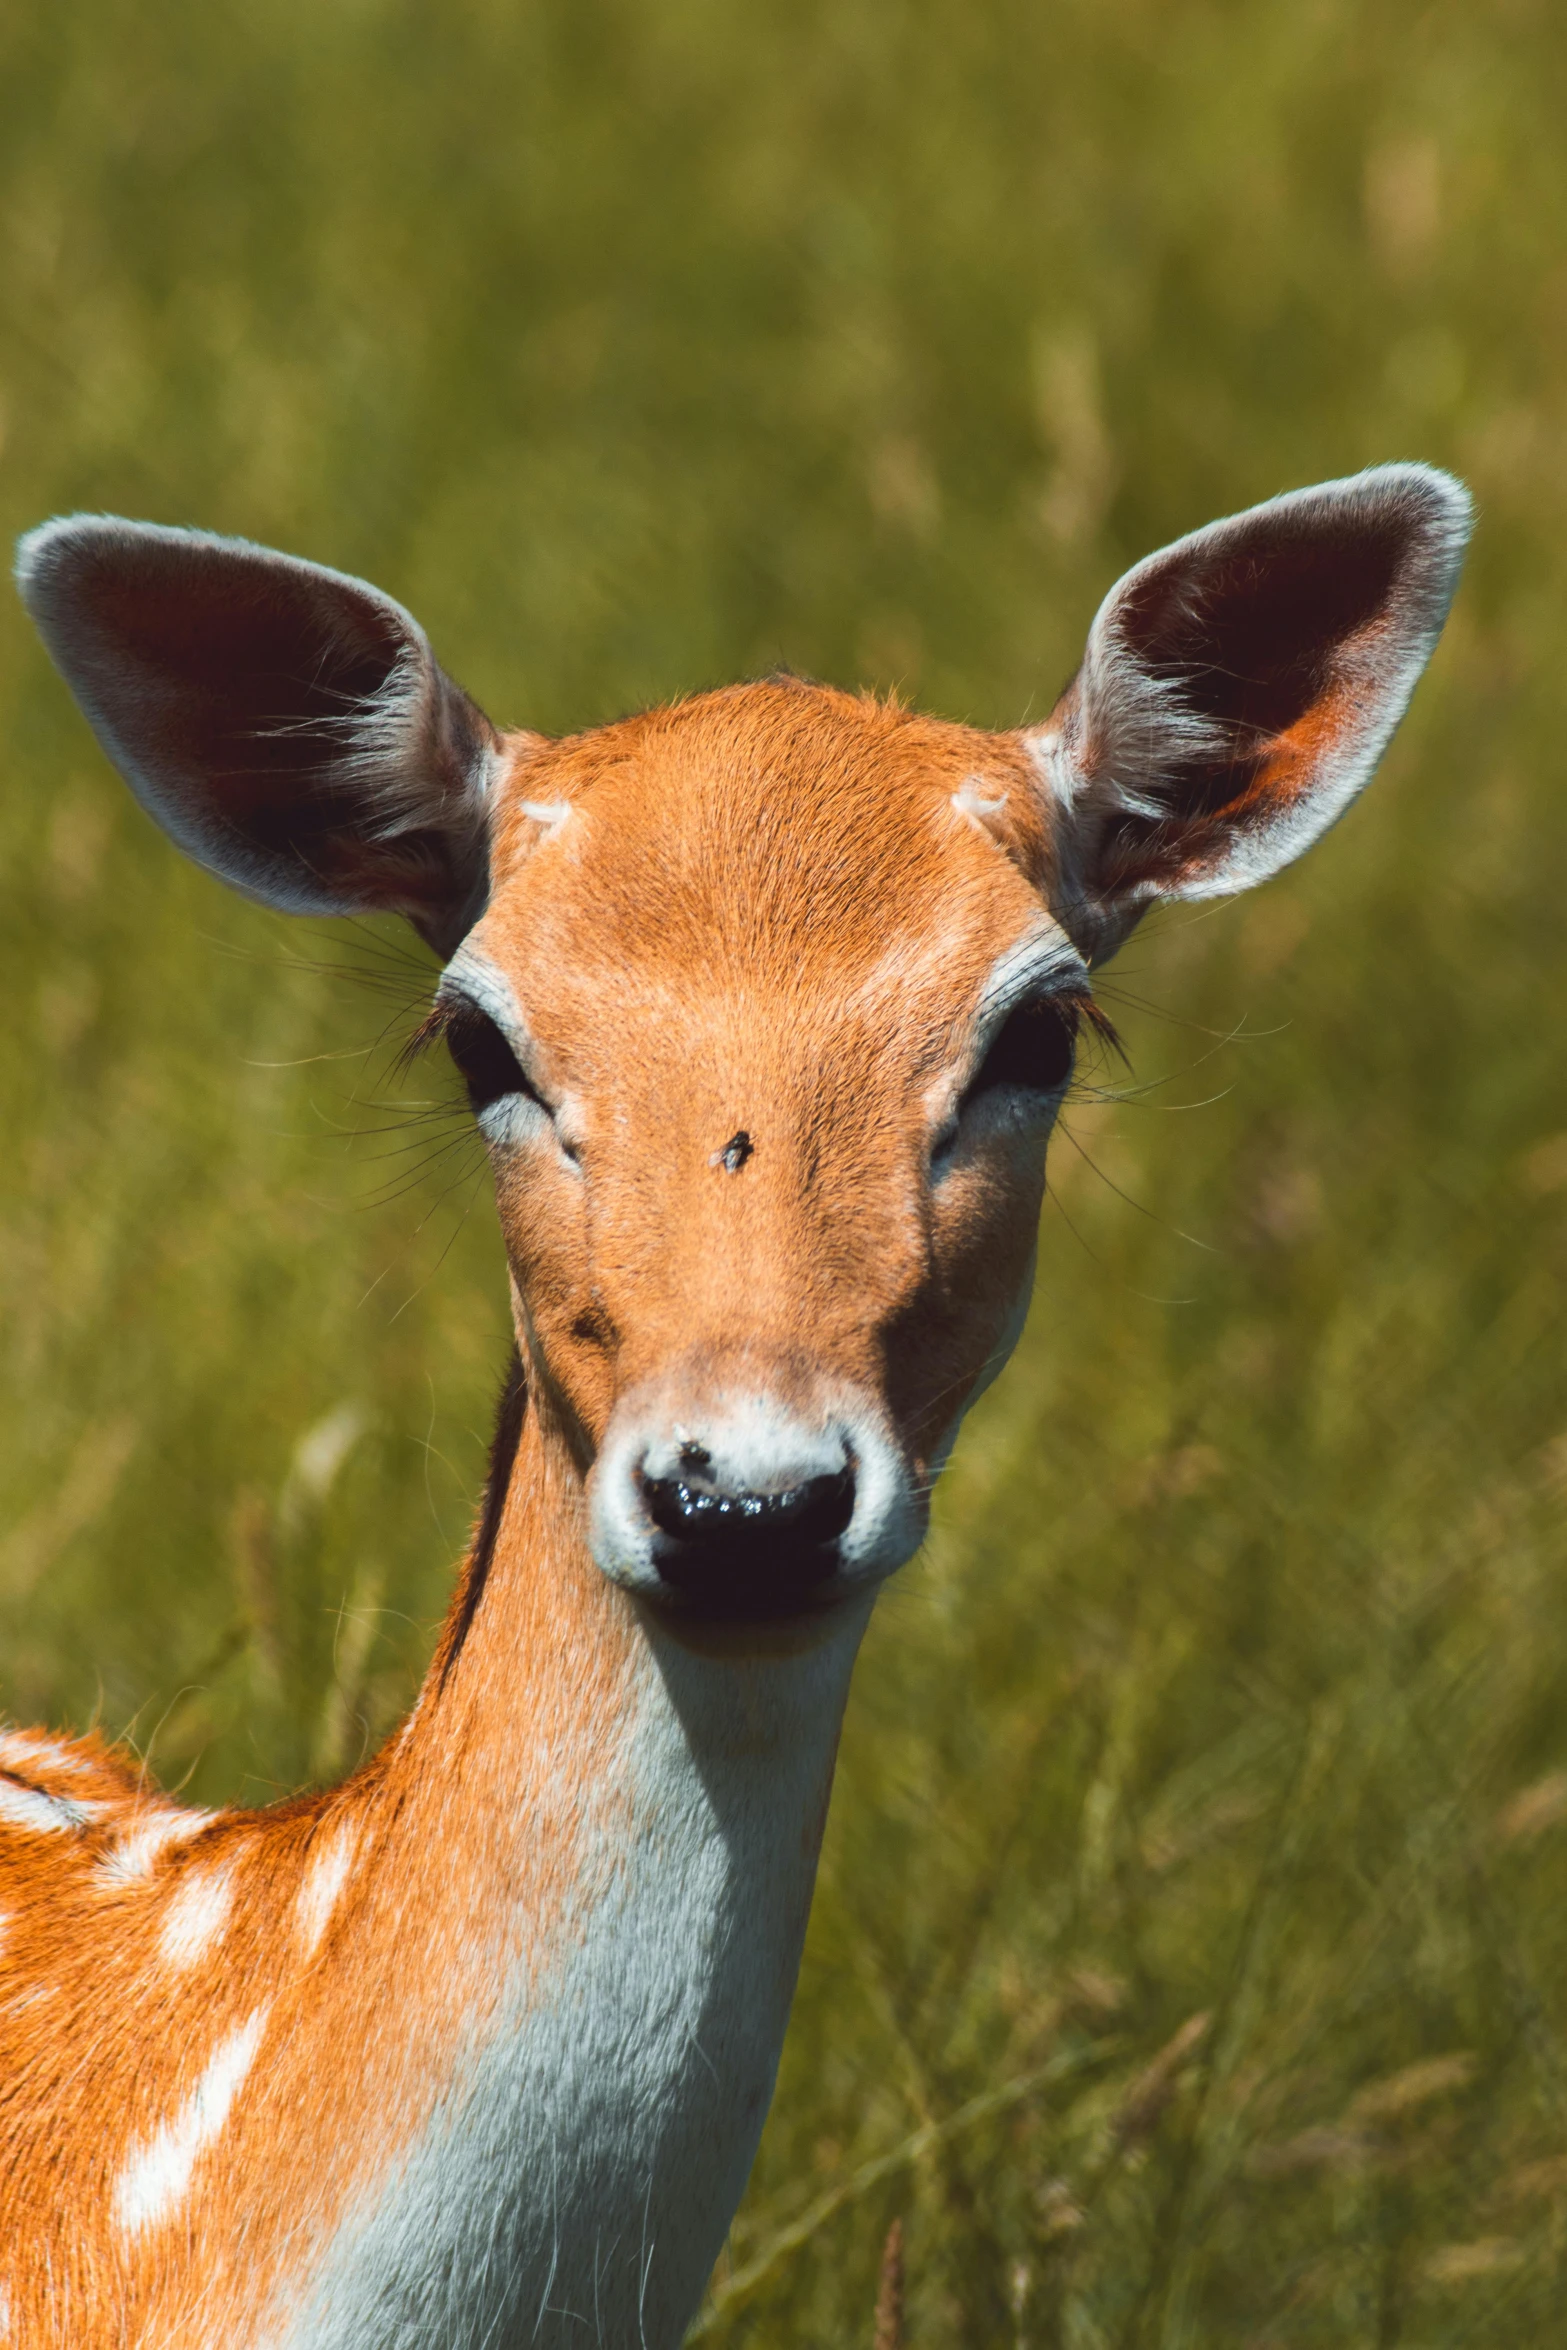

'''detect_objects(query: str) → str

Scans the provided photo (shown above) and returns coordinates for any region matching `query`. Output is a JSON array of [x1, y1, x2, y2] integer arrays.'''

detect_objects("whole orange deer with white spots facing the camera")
[[0, 463, 1471, 2350]]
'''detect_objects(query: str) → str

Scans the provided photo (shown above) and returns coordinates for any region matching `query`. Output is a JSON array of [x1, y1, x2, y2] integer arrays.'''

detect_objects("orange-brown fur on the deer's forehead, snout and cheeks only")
[[475, 684, 1048, 1459]]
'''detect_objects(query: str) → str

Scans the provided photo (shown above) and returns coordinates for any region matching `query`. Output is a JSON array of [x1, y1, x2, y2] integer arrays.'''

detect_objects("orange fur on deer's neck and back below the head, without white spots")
[[0, 1400, 630, 2350]]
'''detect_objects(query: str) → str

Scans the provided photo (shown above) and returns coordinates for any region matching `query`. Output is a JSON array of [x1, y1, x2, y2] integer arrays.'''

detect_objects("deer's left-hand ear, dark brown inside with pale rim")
[[16, 515, 496, 954]]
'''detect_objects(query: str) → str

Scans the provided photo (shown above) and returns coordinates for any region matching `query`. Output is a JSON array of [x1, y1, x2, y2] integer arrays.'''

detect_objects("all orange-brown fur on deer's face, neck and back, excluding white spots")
[[0, 684, 1066, 2350]]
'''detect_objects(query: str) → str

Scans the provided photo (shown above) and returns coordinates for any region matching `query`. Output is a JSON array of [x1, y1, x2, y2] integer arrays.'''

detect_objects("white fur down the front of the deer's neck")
[[261, 1603, 869, 2350]]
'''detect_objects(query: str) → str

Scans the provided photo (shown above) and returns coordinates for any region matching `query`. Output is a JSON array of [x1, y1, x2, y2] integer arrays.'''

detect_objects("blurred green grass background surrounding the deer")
[[0, 0, 1567, 2350]]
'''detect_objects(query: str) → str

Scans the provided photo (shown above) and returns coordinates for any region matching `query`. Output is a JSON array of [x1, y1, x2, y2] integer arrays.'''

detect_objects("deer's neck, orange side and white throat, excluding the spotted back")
[[282, 1372, 865, 2350]]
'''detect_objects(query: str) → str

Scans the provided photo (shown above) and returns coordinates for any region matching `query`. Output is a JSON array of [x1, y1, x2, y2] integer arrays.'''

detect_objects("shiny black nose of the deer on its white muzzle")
[[641, 1469, 855, 1619]]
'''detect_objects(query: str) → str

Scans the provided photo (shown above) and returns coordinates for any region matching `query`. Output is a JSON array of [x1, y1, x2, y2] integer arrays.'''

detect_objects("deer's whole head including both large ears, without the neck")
[[19, 465, 1468, 1619]]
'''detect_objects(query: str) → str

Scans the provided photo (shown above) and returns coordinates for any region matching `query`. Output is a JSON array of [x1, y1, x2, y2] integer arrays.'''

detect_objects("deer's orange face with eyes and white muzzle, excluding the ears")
[[437, 684, 1071, 1612]]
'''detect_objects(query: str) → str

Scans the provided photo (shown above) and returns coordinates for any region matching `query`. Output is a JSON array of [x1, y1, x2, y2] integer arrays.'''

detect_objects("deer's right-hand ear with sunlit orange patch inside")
[[1024, 465, 1471, 954]]
